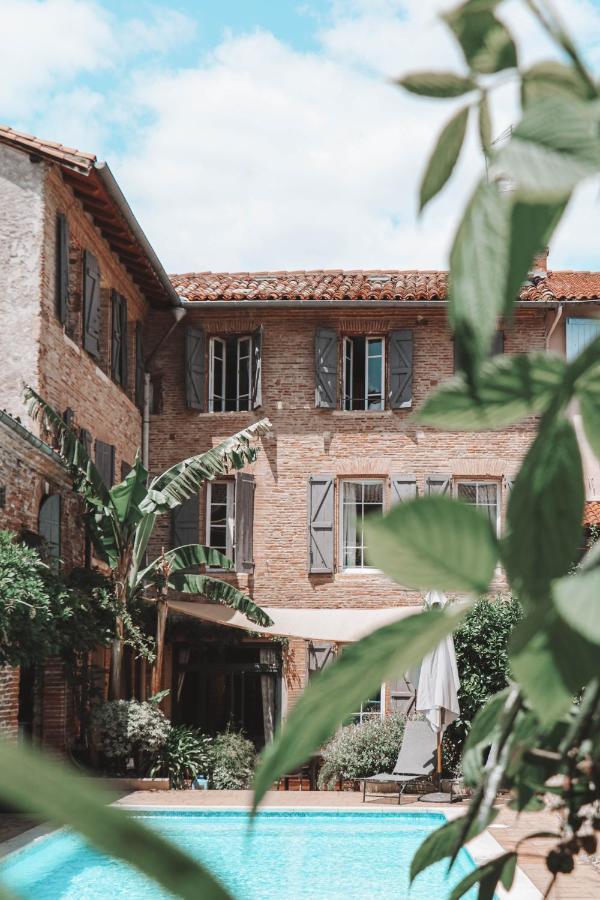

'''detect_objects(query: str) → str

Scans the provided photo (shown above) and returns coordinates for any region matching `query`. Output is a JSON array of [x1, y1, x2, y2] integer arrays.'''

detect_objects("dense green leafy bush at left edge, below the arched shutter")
[[0, 531, 115, 666]]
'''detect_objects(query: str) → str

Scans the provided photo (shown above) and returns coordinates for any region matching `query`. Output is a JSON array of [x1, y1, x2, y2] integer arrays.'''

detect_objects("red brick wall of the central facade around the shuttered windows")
[[144, 309, 546, 702]]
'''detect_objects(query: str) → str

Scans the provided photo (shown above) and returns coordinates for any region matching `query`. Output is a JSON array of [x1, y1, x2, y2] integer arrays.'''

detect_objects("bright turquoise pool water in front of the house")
[[0, 810, 477, 900]]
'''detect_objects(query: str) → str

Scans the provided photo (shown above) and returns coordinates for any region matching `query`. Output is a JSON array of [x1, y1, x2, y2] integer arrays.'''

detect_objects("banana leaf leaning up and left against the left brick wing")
[[24, 387, 113, 510]]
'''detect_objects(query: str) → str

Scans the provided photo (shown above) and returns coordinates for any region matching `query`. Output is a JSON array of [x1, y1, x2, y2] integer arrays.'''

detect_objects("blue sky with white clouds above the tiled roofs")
[[0, 0, 600, 271]]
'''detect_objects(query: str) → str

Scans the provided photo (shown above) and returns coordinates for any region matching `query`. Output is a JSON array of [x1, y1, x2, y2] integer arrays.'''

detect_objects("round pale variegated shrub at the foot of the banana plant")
[[91, 700, 171, 772]]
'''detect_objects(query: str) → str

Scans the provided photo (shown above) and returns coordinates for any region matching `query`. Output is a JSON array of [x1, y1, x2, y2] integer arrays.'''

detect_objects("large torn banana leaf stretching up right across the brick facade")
[[140, 419, 271, 513]]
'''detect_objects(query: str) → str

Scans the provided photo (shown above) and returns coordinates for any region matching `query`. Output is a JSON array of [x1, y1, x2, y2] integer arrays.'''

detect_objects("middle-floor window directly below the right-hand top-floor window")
[[340, 481, 383, 569]]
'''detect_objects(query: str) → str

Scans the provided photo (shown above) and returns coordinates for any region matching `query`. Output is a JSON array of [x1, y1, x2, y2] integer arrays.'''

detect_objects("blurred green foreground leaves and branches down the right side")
[[255, 0, 600, 900]]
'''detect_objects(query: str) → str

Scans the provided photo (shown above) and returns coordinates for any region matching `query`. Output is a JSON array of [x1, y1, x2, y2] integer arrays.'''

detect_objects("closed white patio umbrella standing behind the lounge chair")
[[415, 591, 460, 800]]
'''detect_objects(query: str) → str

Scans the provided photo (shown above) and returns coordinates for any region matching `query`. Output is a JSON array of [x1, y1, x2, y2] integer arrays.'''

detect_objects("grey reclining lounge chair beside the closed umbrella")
[[363, 722, 436, 805]]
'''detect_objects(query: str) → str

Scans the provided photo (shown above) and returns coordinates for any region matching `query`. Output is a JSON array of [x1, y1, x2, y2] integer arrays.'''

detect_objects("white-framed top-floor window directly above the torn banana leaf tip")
[[208, 335, 253, 412]]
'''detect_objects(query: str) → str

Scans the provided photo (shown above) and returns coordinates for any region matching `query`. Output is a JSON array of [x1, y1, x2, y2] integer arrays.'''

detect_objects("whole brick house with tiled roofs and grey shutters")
[[0, 123, 600, 743]]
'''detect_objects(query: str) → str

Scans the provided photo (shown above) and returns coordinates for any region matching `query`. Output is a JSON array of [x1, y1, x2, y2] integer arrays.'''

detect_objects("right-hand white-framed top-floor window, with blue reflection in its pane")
[[344, 335, 385, 410]]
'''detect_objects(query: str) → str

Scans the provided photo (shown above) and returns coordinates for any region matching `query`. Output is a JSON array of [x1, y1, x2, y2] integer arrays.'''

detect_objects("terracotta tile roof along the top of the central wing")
[[171, 269, 600, 303]]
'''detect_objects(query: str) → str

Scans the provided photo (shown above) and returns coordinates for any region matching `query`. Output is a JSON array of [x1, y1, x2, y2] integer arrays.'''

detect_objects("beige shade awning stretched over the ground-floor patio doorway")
[[169, 600, 422, 644]]
